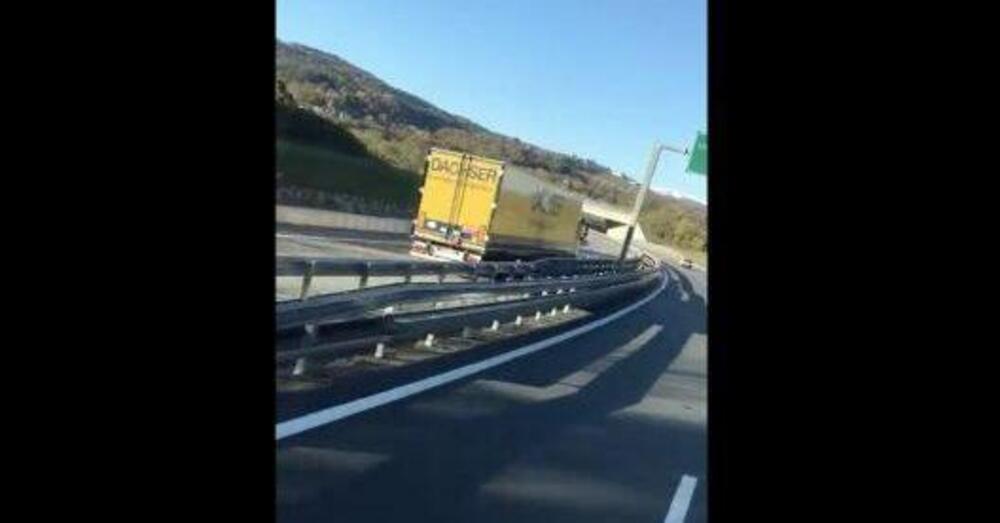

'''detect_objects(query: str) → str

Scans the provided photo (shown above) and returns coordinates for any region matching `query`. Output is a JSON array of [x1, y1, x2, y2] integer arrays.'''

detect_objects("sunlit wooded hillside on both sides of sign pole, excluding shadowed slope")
[[275, 41, 707, 253]]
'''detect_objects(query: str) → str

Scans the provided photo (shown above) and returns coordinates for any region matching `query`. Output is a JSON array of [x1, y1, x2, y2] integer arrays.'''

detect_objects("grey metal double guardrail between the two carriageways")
[[276, 255, 665, 375]]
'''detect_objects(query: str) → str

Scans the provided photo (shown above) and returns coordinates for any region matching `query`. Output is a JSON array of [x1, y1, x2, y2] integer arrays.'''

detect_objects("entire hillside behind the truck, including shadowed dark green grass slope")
[[275, 41, 707, 251]]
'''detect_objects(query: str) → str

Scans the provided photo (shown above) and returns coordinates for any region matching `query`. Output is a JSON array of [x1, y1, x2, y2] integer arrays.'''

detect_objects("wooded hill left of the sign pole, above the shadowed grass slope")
[[275, 41, 631, 198]]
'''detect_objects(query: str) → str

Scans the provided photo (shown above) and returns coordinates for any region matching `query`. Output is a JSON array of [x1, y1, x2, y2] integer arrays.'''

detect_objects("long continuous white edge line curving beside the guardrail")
[[274, 274, 669, 441]]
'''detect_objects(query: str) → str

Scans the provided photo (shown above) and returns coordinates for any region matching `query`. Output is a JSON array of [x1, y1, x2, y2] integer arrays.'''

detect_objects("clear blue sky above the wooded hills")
[[277, 0, 708, 201]]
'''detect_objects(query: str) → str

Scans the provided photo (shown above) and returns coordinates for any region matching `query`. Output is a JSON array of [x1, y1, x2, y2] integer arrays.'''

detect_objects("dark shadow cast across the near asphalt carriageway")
[[278, 270, 706, 523]]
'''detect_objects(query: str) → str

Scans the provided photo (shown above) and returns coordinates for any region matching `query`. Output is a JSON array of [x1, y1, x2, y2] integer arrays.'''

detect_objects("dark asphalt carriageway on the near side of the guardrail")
[[276, 269, 708, 523]]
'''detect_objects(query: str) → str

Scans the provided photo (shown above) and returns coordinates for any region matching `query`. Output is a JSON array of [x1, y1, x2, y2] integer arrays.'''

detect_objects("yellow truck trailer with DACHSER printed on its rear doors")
[[412, 148, 585, 262]]
